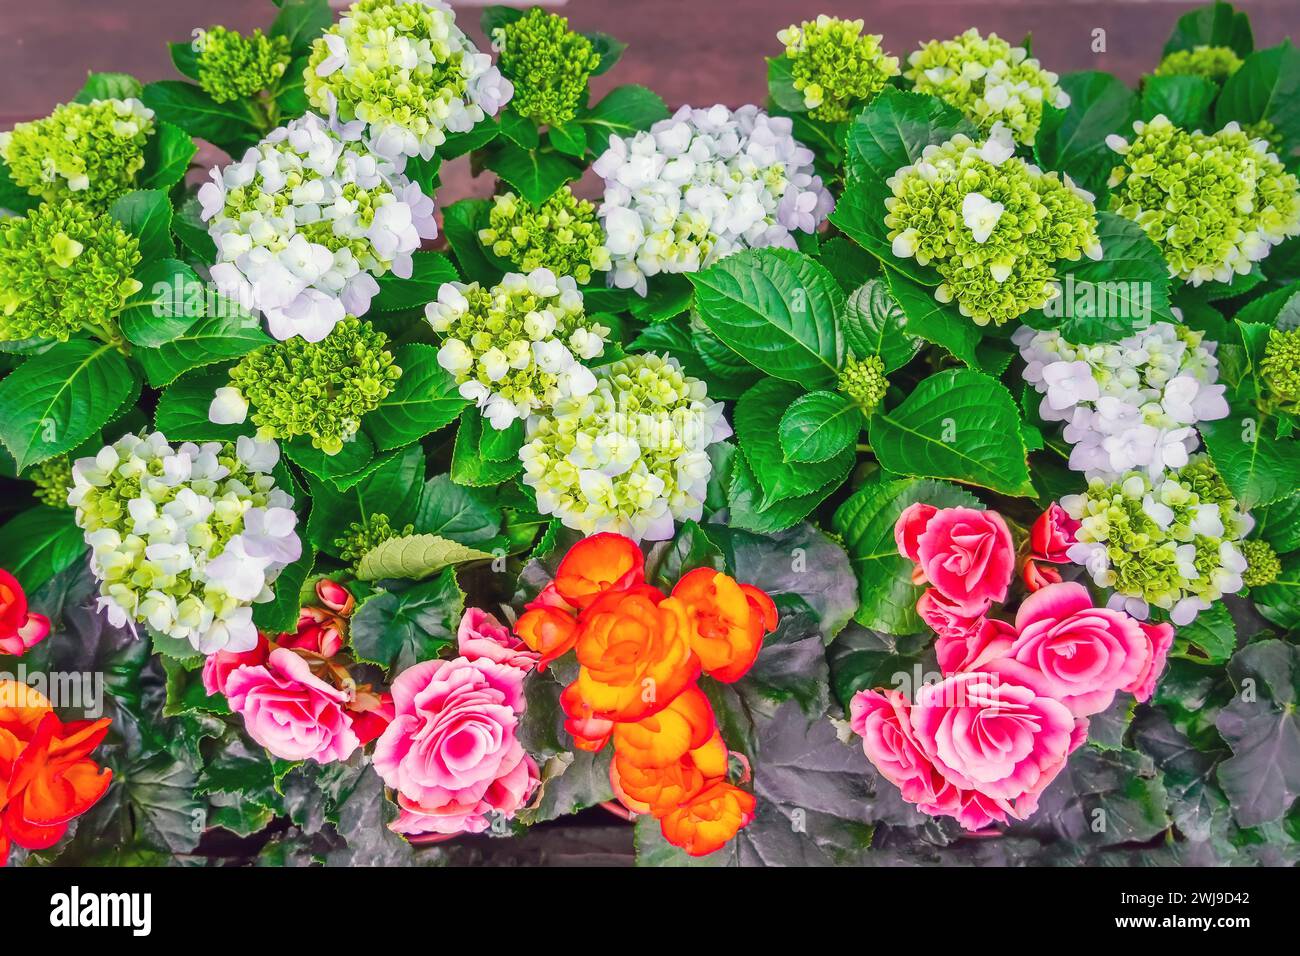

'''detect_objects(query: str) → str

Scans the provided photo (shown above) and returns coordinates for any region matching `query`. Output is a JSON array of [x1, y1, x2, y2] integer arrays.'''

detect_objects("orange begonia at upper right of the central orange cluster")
[[672, 567, 776, 684]]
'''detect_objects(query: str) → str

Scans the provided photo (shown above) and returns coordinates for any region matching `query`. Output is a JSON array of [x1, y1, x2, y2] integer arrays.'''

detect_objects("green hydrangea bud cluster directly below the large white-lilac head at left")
[[230, 316, 402, 455]]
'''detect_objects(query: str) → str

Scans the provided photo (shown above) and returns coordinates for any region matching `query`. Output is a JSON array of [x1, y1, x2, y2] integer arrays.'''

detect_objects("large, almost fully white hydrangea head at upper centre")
[[592, 105, 833, 295]]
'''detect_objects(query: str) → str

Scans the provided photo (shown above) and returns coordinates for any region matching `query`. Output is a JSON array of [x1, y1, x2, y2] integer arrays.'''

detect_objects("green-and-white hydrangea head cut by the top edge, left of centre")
[[304, 0, 514, 169]]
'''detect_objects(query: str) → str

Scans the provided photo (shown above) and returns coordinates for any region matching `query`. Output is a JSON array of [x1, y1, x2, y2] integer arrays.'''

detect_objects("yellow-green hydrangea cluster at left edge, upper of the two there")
[[0, 98, 153, 208]]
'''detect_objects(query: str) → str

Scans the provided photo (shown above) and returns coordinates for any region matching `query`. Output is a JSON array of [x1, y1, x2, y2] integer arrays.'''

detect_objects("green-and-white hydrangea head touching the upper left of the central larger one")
[[425, 269, 610, 428]]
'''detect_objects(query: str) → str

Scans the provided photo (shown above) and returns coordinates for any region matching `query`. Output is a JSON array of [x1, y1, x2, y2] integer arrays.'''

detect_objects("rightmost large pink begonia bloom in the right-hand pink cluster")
[[972, 583, 1153, 717]]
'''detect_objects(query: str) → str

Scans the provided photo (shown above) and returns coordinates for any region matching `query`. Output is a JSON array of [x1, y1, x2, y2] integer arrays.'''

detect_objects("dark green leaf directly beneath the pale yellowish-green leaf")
[[348, 568, 465, 671]]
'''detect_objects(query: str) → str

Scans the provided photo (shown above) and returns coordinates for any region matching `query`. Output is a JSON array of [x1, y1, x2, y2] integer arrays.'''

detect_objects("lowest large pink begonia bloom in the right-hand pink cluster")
[[909, 671, 1087, 818]]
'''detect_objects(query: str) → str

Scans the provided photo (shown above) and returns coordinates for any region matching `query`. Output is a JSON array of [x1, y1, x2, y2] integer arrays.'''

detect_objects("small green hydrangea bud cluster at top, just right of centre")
[[776, 13, 898, 122]]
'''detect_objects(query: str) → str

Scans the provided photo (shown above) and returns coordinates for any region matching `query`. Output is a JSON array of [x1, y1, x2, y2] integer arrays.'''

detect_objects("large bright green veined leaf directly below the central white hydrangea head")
[[689, 248, 844, 388]]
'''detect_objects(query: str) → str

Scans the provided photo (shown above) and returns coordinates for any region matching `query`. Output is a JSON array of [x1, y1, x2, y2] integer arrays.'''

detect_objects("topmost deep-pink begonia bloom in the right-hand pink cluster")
[[894, 505, 1015, 617]]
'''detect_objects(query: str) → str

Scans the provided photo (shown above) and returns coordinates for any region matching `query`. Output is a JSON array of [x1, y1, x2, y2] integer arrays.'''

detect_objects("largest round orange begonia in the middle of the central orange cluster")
[[575, 584, 699, 722]]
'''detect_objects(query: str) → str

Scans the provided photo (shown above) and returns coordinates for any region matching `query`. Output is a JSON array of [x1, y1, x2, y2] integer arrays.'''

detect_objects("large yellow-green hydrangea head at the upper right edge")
[[1106, 114, 1300, 285]]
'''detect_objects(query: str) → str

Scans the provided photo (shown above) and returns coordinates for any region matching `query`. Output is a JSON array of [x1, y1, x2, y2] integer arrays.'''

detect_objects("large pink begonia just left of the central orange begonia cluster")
[[374, 657, 538, 836]]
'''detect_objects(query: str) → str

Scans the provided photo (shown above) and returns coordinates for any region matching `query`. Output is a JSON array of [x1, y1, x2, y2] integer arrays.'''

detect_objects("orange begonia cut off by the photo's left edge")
[[0, 680, 113, 864]]
